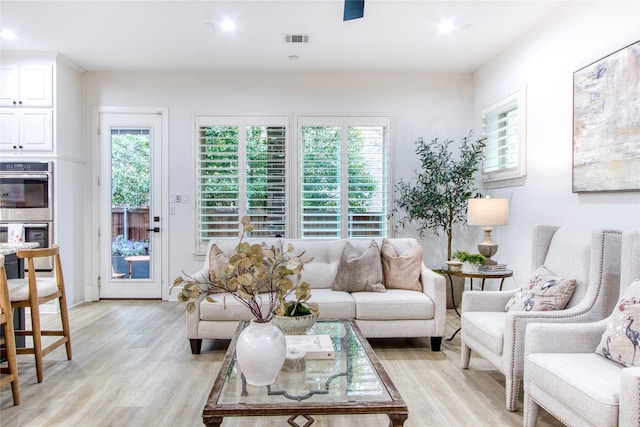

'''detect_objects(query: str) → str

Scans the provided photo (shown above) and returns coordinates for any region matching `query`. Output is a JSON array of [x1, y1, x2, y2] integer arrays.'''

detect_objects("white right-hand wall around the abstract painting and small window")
[[474, 1, 640, 287]]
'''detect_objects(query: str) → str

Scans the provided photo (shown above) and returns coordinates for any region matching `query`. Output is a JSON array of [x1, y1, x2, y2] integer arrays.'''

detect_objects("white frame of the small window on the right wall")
[[481, 86, 527, 188]]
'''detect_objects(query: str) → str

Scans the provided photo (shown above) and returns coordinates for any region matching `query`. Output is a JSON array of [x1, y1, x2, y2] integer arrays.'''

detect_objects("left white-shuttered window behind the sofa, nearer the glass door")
[[196, 117, 288, 251]]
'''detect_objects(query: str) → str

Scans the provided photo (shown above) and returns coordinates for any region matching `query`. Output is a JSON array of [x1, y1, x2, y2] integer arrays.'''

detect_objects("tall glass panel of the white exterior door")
[[111, 128, 153, 280]]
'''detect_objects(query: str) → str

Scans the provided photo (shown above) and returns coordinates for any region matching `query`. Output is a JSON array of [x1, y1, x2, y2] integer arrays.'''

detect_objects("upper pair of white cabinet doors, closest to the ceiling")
[[0, 64, 53, 107]]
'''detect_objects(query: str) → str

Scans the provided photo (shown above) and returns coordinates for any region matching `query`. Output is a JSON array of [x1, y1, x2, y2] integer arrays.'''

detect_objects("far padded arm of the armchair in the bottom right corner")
[[524, 319, 608, 358]]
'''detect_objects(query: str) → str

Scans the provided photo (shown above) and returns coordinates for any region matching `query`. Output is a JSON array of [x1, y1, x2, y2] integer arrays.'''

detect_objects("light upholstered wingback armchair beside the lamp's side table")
[[461, 225, 621, 411]]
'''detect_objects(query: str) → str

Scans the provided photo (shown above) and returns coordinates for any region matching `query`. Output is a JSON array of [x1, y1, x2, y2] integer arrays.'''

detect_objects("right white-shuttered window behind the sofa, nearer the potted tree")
[[298, 117, 389, 238]]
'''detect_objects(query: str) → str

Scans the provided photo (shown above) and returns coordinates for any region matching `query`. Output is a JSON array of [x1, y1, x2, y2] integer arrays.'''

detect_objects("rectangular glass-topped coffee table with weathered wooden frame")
[[202, 320, 409, 427]]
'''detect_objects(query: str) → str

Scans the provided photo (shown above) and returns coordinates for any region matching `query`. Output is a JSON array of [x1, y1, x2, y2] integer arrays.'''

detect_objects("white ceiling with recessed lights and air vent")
[[0, 0, 566, 73]]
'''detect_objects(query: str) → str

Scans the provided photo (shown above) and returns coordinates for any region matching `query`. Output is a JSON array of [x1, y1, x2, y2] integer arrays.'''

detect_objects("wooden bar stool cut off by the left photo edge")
[[0, 255, 20, 405]]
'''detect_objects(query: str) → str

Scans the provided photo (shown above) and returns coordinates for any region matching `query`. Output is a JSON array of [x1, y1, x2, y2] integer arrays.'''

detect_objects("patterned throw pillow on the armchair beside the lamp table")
[[504, 265, 576, 311]]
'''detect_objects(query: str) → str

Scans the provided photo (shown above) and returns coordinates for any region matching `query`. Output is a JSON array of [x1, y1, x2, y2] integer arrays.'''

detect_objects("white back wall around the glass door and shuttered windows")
[[84, 72, 478, 298]]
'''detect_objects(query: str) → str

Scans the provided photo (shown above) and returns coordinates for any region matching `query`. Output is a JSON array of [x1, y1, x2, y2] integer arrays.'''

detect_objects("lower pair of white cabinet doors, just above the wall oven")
[[0, 108, 53, 152]]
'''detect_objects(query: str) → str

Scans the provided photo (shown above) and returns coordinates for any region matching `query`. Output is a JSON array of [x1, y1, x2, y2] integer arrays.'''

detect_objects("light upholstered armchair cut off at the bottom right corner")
[[524, 231, 640, 427]]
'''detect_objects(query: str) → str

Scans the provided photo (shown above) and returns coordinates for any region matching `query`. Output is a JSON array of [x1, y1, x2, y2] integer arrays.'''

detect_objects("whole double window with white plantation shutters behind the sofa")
[[196, 116, 390, 252]]
